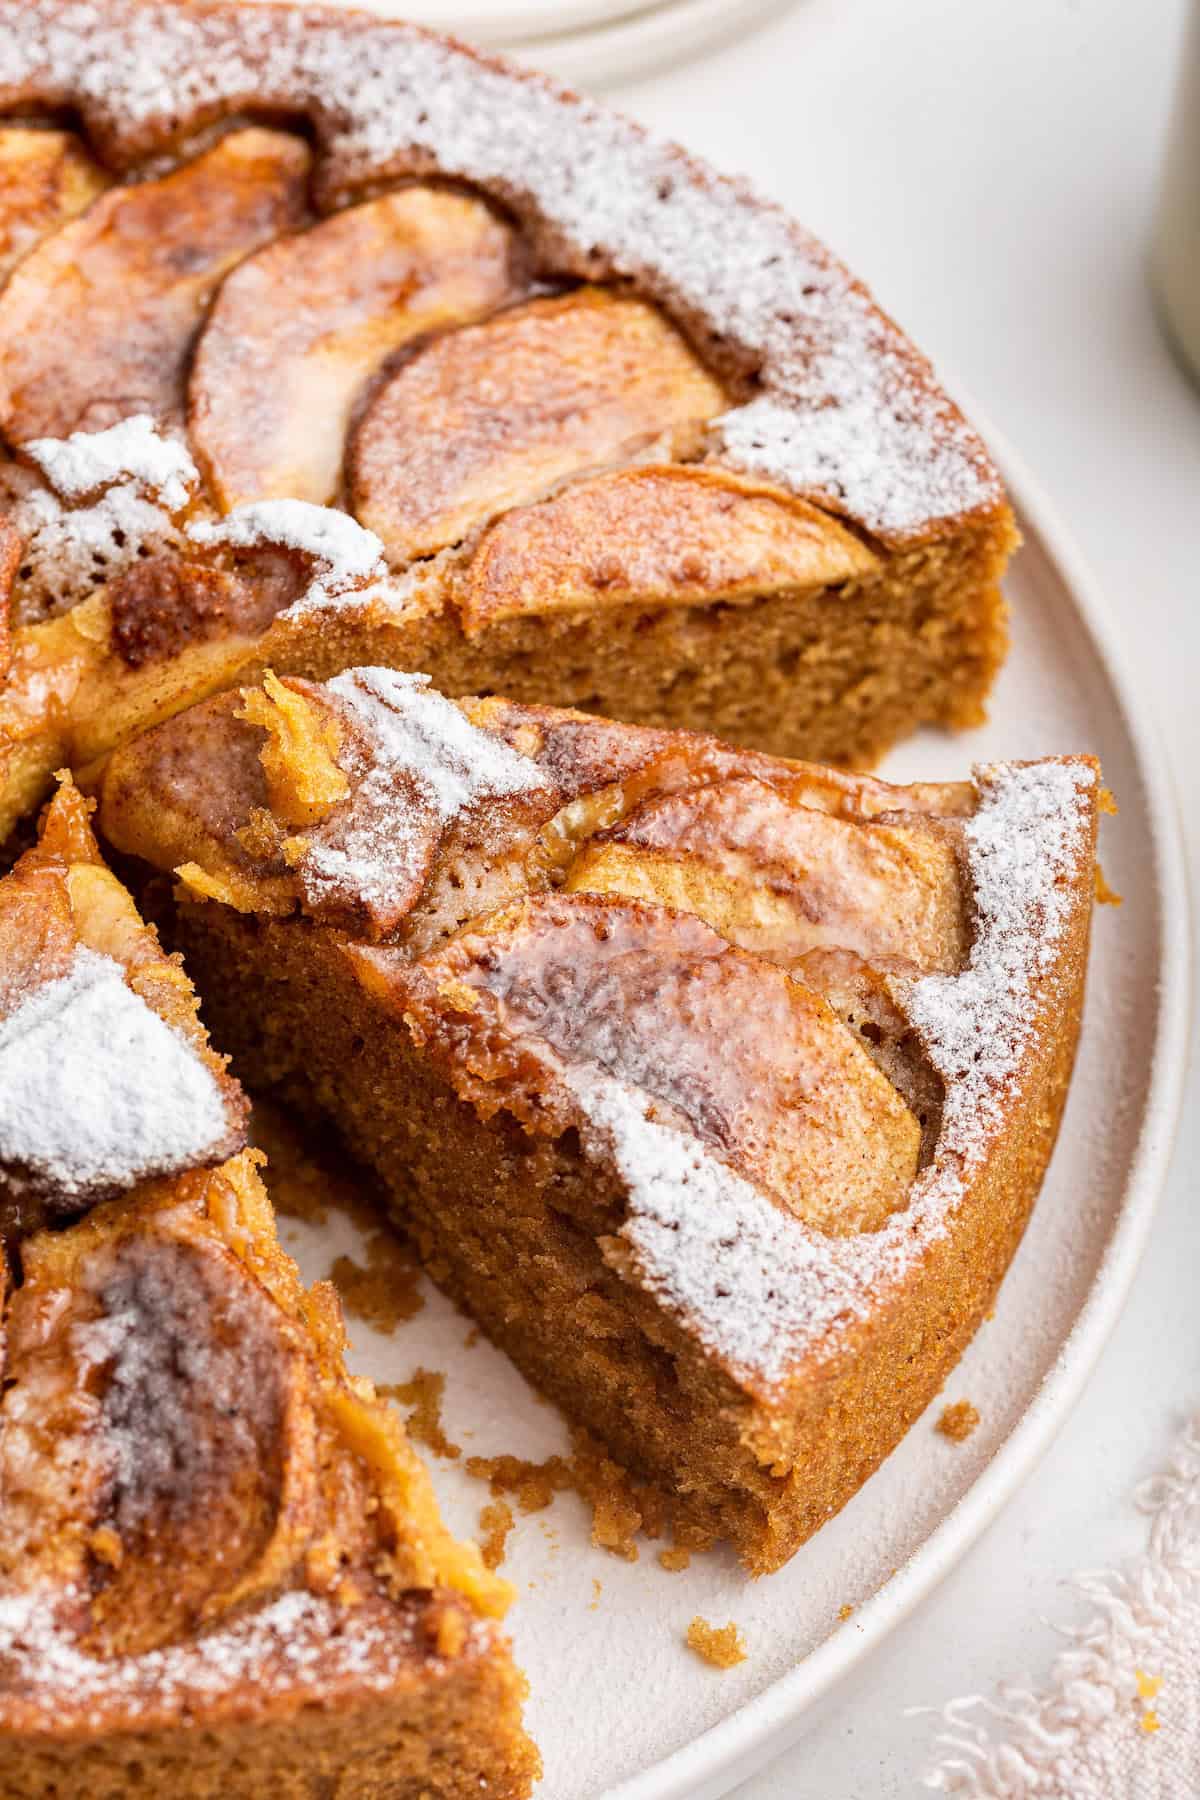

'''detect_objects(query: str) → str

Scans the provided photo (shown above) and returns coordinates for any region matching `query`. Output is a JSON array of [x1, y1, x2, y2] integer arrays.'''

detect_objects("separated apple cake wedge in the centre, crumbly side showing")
[[99, 668, 1099, 1571]]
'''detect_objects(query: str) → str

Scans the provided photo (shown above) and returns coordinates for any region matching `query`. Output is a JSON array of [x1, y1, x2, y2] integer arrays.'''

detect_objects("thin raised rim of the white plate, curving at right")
[[597, 421, 1193, 1800]]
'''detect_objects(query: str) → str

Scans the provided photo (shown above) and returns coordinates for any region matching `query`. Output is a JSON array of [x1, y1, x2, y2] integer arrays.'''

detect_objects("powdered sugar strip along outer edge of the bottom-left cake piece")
[[0, 1589, 447, 1728]]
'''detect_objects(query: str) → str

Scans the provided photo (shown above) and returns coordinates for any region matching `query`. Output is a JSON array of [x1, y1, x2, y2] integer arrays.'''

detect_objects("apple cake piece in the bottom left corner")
[[0, 785, 538, 1800]]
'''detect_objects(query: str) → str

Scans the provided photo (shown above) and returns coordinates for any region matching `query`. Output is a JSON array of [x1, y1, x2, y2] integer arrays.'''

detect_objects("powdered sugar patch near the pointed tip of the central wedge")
[[299, 668, 549, 911]]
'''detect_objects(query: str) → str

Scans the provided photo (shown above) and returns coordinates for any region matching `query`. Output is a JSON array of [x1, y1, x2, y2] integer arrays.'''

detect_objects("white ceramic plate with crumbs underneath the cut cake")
[[284, 434, 1187, 1800]]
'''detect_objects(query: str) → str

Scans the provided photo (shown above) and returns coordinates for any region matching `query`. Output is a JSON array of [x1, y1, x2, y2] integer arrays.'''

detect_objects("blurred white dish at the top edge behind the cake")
[[305, 0, 792, 88]]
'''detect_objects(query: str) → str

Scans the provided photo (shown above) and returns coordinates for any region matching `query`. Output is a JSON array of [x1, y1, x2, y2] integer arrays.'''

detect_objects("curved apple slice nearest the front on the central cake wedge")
[[394, 893, 921, 1233]]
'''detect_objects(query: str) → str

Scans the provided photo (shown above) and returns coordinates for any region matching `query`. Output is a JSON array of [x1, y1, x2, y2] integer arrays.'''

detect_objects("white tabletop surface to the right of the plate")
[[597, 0, 1200, 1800]]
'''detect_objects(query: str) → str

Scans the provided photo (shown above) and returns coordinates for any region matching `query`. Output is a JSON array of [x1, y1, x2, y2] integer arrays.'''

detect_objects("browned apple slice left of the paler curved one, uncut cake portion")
[[0, 126, 311, 445]]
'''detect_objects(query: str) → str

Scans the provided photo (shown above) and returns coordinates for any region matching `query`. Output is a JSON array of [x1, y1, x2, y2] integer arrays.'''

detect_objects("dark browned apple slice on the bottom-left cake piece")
[[0, 1170, 318, 1656]]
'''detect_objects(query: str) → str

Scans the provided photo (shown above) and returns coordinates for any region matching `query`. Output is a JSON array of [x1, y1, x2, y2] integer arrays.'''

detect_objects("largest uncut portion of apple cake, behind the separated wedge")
[[0, 0, 1015, 839]]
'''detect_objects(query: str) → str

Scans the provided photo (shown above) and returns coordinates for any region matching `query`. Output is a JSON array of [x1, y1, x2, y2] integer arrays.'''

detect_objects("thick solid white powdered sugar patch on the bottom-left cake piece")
[[0, 947, 230, 1199]]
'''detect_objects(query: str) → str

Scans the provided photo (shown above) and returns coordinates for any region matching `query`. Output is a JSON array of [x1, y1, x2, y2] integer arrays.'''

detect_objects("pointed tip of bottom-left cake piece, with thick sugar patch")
[[0, 781, 246, 1235]]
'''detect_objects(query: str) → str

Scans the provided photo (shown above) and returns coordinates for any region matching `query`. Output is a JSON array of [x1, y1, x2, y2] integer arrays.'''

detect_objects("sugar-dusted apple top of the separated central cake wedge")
[[101, 670, 1097, 1393]]
